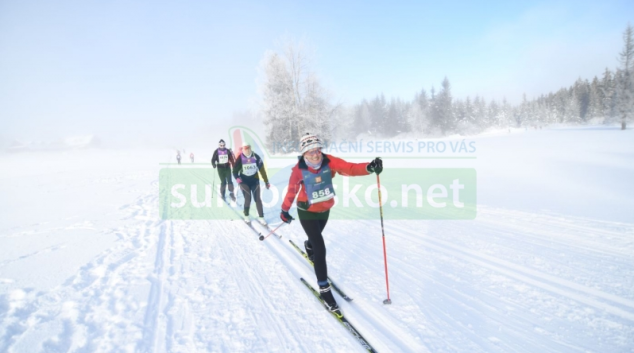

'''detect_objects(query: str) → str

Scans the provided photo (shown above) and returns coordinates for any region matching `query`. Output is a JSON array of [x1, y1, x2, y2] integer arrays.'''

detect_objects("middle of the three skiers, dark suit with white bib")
[[233, 144, 271, 225]]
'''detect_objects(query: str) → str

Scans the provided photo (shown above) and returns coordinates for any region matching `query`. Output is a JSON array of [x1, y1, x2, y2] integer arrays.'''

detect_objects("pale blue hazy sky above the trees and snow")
[[0, 0, 634, 144]]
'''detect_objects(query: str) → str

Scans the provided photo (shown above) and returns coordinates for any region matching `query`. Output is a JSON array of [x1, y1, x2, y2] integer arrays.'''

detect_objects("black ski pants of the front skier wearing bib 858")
[[297, 208, 330, 282]]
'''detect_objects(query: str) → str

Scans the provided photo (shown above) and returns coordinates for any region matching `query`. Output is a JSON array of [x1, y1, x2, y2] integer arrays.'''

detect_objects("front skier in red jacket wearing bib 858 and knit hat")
[[280, 134, 383, 315]]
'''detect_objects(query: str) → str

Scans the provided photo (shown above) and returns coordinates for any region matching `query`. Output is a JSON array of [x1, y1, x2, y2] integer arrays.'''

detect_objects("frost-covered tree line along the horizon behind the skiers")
[[261, 25, 634, 152]]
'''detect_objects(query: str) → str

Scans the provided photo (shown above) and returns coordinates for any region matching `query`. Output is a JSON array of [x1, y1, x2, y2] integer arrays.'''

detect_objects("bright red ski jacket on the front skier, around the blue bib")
[[282, 153, 370, 212]]
